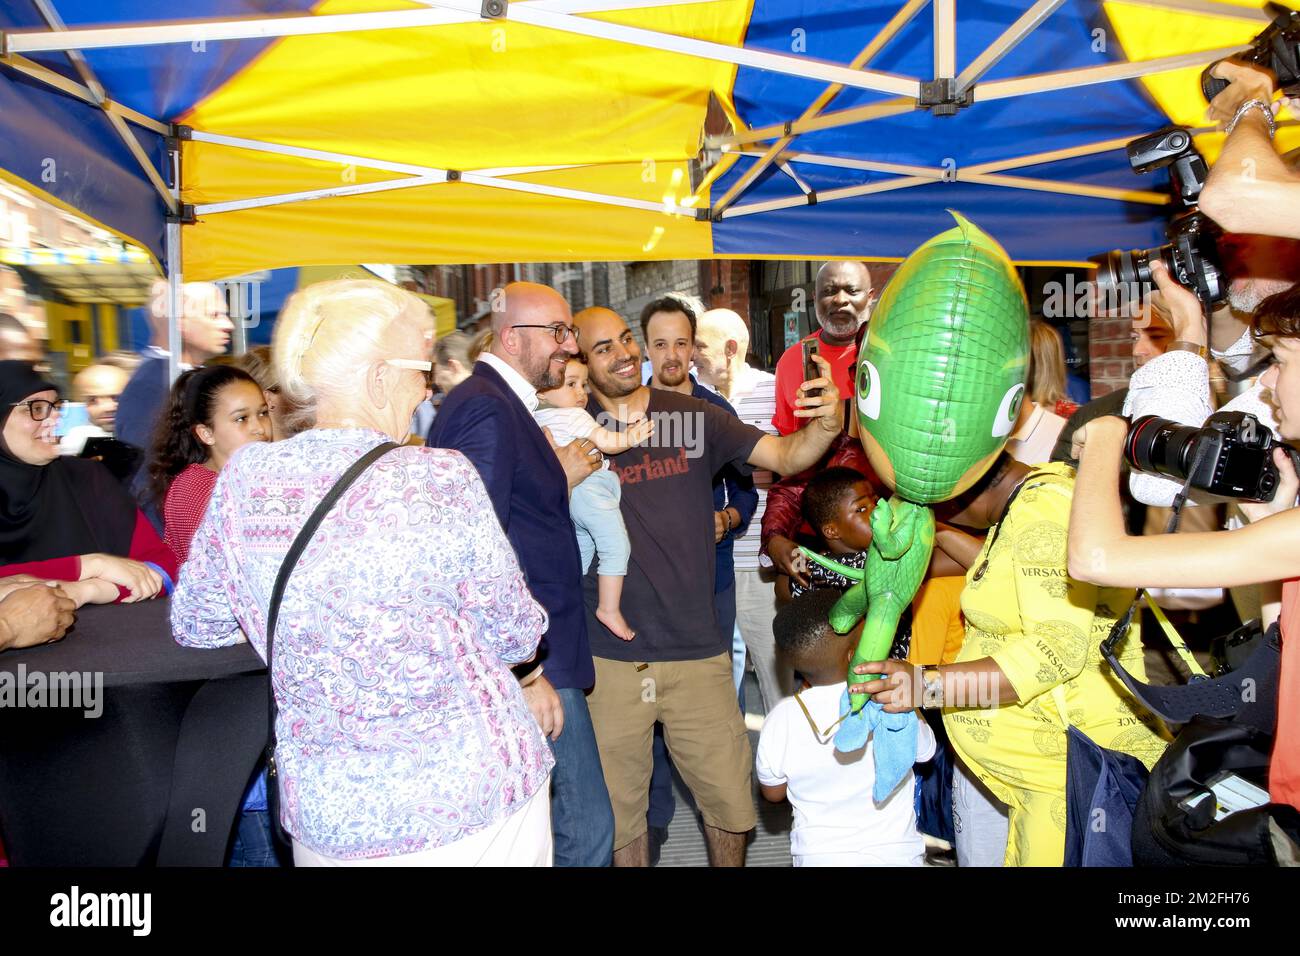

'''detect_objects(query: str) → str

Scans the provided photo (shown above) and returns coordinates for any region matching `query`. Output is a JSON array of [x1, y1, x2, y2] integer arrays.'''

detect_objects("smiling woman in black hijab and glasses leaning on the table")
[[0, 362, 177, 606]]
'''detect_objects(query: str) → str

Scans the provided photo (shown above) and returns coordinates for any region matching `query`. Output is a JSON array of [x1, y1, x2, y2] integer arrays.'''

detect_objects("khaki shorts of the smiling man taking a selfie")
[[586, 654, 758, 849]]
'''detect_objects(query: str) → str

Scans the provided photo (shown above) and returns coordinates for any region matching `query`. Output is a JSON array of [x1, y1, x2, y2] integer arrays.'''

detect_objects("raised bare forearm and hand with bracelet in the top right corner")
[[1201, 60, 1300, 239]]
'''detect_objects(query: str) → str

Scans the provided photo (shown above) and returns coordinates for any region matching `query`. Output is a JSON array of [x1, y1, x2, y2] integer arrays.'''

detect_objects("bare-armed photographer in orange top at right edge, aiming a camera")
[[1069, 289, 1300, 808]]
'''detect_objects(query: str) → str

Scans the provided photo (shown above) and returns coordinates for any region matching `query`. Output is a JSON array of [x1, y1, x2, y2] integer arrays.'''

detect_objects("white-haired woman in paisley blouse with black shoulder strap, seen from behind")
[[172, 280, 554, 865]]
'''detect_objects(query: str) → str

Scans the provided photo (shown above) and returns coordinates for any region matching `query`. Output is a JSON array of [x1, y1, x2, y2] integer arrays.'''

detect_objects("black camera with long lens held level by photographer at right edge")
[[1125, 411, 1296, 501]]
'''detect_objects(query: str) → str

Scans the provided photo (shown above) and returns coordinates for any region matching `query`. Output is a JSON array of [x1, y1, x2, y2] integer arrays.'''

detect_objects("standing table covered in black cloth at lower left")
[[0, 600, 267, 866]]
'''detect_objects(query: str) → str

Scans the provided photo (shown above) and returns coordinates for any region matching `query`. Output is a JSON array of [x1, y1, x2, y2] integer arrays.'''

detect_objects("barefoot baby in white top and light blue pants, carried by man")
[[533, 358, 654, 641]]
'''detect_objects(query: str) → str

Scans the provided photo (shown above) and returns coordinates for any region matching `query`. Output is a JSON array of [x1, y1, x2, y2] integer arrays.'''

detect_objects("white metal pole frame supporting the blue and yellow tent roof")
[[0, 0, 1269, 378]]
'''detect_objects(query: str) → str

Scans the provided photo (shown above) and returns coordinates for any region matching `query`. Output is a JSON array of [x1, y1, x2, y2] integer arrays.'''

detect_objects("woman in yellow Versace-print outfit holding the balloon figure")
[[850, 454, 1166, 866]]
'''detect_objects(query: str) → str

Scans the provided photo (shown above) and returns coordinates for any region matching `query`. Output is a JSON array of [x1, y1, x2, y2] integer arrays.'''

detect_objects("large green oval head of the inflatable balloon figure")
[[857, 212, 1030, 505]]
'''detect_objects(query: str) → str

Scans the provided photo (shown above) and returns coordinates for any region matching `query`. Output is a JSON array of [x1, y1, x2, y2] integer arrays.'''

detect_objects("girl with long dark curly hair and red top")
[[148, 365, 272, 564]]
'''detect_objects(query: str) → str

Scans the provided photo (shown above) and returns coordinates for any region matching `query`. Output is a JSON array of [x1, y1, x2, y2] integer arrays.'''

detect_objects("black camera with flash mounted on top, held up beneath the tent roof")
[[1092, 126, 1227, 307]]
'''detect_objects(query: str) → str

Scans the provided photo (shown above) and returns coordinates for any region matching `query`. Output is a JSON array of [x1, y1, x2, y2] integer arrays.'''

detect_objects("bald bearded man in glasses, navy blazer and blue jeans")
[[428, 282, 614, 866]]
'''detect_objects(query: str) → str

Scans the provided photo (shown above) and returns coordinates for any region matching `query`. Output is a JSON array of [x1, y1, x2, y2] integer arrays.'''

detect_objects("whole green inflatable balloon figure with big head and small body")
[[803, 212, 1030, 713]]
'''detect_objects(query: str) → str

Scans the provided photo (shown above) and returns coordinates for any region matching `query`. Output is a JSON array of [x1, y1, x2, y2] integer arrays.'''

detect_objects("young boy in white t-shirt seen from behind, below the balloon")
[[755, 591, 935, 866]]
